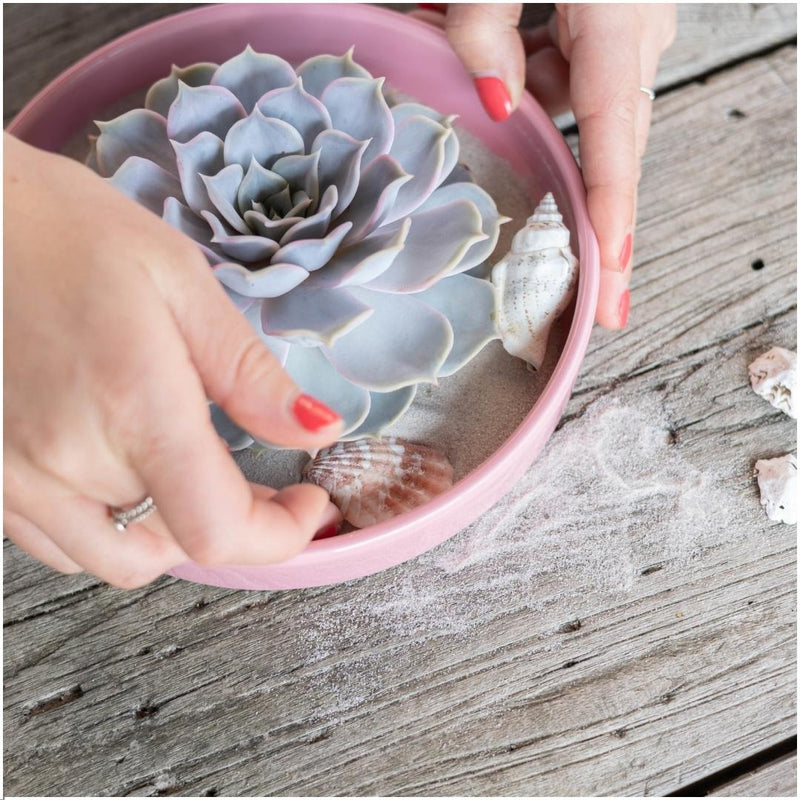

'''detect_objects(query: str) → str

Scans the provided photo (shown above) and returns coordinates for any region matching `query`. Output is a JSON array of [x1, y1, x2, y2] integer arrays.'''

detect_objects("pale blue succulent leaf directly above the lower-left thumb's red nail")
[[284, 345, 370, 435]]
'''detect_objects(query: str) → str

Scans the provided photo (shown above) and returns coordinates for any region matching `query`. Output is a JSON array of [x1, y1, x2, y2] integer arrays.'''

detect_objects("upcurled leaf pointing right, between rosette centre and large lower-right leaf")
[[309, 219, 411, 288]]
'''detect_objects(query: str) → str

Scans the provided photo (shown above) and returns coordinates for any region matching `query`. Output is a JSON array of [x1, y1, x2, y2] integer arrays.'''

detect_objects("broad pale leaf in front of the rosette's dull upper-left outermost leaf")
[[167, 82, 246, 142]]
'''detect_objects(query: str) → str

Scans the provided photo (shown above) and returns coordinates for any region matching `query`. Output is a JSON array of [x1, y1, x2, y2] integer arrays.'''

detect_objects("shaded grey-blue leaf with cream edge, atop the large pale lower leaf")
[[261, 286, 372, 345]]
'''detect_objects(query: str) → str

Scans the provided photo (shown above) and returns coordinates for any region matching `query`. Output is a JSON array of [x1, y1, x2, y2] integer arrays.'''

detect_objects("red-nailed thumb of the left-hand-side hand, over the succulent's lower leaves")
[[156, 241, 342, 450]]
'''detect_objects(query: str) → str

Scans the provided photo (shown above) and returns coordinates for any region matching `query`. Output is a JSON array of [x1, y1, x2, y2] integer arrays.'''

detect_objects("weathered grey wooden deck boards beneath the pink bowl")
[[4, 4, 797, 796]]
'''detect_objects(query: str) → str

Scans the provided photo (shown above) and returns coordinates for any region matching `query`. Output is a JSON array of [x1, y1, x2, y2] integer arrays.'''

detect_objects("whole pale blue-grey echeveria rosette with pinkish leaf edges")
[[89, 47, 504, 449]]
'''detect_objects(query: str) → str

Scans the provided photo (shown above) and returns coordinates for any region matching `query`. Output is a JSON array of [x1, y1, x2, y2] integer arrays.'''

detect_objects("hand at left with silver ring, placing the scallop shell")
[[4, 135, 341, 588]]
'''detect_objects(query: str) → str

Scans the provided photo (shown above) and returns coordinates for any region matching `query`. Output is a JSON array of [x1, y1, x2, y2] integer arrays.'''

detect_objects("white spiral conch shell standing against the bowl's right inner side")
[[492, 192, 578, 370]]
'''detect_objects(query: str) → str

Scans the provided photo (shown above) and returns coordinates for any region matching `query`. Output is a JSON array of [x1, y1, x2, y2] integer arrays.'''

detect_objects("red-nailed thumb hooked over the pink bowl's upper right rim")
[[445, 3, 525, 122]]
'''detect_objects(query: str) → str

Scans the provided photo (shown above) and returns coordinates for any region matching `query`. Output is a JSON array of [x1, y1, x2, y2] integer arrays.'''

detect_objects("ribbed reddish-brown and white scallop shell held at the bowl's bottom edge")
[[303, 436, 453, 528]]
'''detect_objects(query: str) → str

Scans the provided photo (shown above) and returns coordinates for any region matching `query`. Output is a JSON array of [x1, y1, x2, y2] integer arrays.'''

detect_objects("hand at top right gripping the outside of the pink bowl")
[[412, 3, 676, 329]]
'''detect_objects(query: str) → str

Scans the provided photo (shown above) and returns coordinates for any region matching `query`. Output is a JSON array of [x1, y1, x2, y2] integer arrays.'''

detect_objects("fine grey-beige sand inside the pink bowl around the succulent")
[[62, 84, 577, 504]]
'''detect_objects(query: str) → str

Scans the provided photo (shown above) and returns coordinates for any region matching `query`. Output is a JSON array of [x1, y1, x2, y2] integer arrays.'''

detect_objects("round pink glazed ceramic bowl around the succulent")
[[9, 4, 599, 589]]
